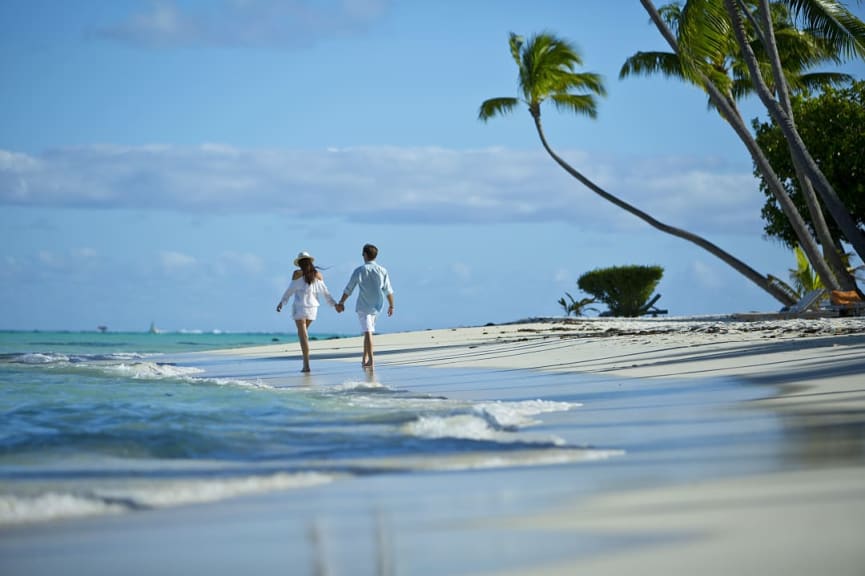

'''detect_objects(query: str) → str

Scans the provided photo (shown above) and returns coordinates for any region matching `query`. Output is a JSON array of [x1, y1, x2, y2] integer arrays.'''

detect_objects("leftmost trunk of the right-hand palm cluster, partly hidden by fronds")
[[640, 0, 839, 290]]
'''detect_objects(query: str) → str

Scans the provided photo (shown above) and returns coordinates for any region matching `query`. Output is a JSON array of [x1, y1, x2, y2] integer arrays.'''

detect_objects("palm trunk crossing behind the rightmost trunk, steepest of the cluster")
[[755, 0, 856, 290]]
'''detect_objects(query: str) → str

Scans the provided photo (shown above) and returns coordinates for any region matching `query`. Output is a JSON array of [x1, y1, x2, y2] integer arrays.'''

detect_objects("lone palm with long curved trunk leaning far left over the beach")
[[478, 33, 793, 305]]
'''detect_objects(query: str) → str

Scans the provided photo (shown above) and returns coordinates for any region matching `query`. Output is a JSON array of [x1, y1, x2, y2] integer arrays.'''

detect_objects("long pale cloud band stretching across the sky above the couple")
[[0, 144, 762, 235]]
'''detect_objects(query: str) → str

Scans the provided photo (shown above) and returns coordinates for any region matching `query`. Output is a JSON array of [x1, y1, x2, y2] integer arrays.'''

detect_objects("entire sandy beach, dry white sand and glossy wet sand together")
[[0, 317, 865, 575]]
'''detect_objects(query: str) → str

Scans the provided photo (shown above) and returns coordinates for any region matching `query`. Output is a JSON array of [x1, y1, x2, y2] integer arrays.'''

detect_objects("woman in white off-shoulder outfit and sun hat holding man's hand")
[[276, 252, 336, 372]]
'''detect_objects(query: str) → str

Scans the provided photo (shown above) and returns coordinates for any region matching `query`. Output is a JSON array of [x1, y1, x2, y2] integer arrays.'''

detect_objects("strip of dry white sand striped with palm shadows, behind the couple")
[[228, 316, 865, 410]]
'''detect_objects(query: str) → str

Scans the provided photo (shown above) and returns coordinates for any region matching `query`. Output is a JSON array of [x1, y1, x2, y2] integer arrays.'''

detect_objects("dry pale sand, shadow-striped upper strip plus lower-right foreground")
[[224, 318, 865, 575]]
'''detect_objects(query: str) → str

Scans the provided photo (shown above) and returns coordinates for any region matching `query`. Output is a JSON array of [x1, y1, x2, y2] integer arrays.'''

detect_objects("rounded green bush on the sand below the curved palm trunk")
[[577, 266, 664, 316]]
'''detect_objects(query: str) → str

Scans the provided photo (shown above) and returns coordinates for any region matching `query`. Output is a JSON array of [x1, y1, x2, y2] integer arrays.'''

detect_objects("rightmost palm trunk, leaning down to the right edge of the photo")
[[724, 0, 865, 260]]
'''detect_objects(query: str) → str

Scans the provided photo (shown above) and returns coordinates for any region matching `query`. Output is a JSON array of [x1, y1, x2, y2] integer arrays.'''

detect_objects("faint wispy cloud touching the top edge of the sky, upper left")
[[95, 0, 389, 48]]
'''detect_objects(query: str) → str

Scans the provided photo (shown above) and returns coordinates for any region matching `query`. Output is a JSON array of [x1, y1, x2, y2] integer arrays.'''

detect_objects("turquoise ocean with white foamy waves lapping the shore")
[[0, 332, 592, 526]]
